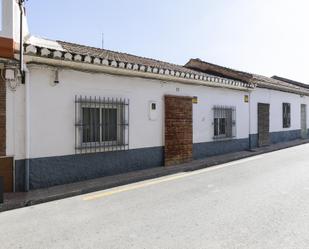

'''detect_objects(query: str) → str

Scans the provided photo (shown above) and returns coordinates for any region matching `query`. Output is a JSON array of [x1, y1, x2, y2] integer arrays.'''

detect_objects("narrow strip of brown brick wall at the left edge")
[[0, 70, 6, 156]]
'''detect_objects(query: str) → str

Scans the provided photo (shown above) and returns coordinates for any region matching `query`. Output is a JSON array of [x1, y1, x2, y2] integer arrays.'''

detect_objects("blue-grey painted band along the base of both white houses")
[[15, 130, 301, 191]]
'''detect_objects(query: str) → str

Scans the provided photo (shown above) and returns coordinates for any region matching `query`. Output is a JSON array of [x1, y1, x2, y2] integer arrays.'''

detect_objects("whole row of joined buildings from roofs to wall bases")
[[0, 0, 309, 191]]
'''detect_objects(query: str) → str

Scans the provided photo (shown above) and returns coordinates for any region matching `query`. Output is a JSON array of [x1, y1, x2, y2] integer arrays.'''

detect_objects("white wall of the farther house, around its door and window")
[[250, 88, 309, 134]]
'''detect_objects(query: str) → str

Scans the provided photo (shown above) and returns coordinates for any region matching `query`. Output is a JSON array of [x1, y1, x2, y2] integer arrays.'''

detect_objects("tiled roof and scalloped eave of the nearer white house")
[[25, 36, 253, 89]]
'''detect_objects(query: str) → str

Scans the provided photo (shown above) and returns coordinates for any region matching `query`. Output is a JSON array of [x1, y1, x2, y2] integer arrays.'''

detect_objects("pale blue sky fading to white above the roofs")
[[26, 0, 309, 83]]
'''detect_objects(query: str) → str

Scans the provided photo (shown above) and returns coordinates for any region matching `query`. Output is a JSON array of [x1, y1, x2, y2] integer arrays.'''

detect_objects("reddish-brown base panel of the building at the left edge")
[[0, 157, 13, 193]]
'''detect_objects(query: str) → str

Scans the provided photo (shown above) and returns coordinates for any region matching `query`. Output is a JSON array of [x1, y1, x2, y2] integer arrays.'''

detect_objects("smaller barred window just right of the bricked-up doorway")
[[213, 106, 236, 139]]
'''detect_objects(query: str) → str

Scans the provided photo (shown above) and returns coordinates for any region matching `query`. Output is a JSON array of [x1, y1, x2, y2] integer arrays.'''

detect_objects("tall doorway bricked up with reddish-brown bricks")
[[165, 95, 192, 166]]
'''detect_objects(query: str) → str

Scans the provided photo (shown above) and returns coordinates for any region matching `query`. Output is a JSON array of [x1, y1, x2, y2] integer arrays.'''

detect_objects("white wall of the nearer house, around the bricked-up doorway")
[[7, 66, 249, 159]]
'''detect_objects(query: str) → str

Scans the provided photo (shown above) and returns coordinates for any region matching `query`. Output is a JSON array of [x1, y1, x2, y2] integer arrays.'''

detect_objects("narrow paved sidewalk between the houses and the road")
[[0, 139, 309, 212]]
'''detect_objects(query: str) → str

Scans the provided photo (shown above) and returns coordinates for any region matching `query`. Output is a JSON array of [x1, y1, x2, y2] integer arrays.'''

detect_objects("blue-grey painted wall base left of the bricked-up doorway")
[[15, 147, 164, 191]]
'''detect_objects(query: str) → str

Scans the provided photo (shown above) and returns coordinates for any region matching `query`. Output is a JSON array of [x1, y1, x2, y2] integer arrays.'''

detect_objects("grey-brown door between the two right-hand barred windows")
[[258, 103, 270, 147]]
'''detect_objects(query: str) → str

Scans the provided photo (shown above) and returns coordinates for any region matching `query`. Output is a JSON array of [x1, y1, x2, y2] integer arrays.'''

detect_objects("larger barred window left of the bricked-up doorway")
[[75, 96, 129, 153]]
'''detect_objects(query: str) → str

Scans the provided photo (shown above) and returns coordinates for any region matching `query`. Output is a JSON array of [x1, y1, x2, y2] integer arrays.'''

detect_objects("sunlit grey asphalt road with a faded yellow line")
[[0, 145, 309, 249]]
